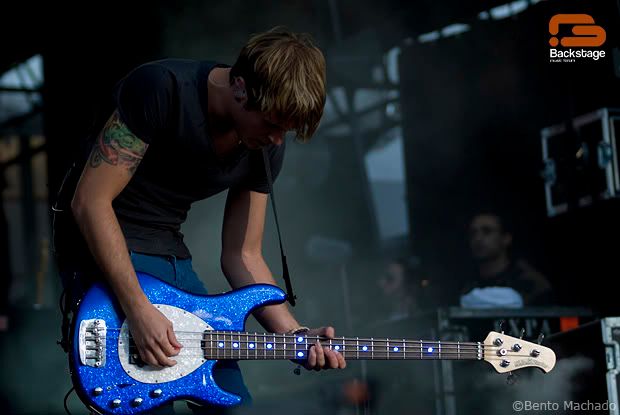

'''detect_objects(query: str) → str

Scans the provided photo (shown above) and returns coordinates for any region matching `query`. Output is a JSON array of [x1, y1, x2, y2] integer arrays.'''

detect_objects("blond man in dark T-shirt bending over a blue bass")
[[54, 28, 346, 413]]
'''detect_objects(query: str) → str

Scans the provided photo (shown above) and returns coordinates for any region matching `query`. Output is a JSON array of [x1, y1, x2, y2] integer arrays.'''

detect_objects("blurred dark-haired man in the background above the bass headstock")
[[460, 211, 553, 308]]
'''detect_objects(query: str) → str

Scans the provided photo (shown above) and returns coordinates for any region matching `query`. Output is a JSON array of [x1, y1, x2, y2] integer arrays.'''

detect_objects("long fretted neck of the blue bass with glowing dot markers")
[[202, 331, 484, 360]]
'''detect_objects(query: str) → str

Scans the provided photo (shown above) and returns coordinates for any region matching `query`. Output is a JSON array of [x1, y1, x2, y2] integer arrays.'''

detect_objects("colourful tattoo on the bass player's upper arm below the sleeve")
[[89, 112, 149, 174]]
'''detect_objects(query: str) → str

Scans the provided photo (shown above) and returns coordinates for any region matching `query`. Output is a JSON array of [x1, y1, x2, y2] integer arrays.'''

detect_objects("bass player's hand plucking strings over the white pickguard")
[[127, 302, 183, 367]]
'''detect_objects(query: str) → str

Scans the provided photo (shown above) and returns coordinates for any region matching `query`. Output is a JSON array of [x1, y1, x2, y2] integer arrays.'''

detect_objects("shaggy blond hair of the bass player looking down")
[[230, 27, 326, 141]]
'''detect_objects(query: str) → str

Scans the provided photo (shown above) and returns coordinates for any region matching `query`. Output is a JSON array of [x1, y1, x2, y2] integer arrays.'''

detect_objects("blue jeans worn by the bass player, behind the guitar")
[[130, 251, 252, 415]]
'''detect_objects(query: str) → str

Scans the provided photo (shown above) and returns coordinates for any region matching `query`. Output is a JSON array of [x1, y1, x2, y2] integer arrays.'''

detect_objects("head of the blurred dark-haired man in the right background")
[[469, 215, 511, 260]]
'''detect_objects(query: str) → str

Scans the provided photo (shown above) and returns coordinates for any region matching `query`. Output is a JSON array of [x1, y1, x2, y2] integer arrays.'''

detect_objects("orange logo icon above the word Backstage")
[[549, 14, 607, 47]]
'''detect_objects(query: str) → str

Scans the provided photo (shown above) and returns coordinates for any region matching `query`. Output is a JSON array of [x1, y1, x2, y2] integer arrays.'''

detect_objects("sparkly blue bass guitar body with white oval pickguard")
[[69, 273, 285, 414]]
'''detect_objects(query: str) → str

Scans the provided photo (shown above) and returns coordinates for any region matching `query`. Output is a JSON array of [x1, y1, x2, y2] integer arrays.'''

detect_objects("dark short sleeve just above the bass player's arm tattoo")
[[114, 63, 175, 143]]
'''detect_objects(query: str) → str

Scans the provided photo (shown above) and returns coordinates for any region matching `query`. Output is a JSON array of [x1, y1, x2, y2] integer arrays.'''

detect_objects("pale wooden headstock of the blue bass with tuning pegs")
[[484, 331, 555, 373]]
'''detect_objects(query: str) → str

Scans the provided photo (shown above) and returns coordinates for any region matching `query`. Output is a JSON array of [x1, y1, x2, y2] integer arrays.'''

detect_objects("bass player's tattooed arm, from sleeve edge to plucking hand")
[[71, 112, 181, 366]]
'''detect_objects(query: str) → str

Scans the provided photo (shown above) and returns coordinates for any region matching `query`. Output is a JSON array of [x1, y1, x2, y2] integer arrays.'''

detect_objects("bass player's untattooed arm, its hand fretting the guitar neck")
[[221, 189, 346, 369]]
